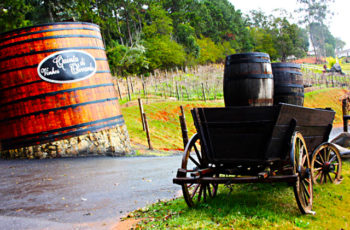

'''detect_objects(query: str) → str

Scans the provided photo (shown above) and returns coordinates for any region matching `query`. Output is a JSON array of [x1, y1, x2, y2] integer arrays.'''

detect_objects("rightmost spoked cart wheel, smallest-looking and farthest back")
[[311, 143, 342, 184]]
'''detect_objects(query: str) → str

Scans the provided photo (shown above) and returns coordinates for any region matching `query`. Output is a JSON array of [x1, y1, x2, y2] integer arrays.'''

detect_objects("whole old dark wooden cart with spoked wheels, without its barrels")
[[173, 103, 341, 214]]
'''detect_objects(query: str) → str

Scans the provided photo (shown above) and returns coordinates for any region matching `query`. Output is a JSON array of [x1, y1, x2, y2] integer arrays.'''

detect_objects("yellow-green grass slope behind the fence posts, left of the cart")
[[122, 101, 224, 151]]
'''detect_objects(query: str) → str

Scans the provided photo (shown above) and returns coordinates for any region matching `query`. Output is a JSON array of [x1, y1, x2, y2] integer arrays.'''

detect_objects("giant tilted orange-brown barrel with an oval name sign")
[[0, 22, 124, 150]]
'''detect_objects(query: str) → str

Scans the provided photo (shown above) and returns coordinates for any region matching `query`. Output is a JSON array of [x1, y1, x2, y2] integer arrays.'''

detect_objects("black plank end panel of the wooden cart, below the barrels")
[[192, 106, 279, 164]]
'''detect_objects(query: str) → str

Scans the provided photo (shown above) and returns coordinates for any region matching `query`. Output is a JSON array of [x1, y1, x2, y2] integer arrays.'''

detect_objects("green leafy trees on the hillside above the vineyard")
[[0, 0, 344, 75]]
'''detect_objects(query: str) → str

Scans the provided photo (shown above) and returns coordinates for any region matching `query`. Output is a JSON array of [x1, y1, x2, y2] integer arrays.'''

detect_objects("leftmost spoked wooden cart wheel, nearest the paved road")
[[182, 133, 218, 207]]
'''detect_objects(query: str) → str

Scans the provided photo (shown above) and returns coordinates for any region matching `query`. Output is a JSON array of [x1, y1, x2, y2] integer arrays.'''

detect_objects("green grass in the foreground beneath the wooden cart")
[[129, 162, 350, 229]]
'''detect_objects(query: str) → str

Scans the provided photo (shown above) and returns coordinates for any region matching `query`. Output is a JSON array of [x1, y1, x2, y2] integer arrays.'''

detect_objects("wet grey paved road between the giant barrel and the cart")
[[0, 156, 181, 230]]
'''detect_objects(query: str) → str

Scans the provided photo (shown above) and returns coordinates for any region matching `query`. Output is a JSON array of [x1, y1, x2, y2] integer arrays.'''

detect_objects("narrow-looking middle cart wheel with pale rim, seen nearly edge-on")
[[290, 132, 314, 214]]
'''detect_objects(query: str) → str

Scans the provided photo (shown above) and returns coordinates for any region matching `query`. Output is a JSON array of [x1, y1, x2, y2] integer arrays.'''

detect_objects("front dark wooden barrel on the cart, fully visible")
[[224, 52, 273, 106]]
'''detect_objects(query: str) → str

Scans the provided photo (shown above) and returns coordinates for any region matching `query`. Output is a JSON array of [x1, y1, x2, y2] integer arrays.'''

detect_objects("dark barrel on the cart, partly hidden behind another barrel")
[[271, 62, 304, 106]]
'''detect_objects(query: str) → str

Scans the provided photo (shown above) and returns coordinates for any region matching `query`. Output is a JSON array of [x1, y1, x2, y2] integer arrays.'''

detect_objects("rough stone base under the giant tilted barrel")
[[0, 124, 133, 159]]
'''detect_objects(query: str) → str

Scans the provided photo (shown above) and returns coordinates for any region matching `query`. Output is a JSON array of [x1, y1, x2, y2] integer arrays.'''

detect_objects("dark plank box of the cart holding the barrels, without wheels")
[[192, 103, 335, 164]]
